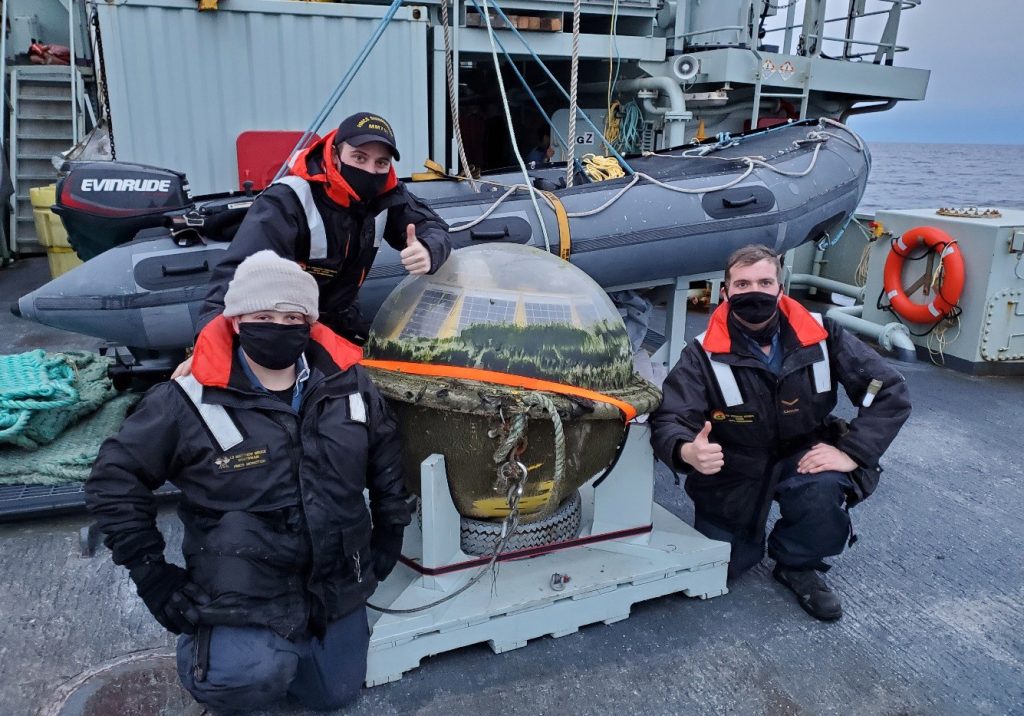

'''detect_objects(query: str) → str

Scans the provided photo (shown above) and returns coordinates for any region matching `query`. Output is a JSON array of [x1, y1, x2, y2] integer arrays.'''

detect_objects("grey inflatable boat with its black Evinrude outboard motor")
[[11, 119, 870, 368]]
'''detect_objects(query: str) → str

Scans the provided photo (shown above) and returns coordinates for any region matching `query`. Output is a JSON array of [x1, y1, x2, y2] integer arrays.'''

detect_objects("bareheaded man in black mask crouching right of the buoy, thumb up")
[[651, 246, 910, 620]]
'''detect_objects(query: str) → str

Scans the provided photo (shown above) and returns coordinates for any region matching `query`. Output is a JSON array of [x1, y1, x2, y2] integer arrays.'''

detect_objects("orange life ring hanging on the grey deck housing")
[[882, 226, 964, 324]]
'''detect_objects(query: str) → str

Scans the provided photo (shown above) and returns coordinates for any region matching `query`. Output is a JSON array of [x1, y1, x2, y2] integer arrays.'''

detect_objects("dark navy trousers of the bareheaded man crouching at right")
[[693, 458, 853, 578]]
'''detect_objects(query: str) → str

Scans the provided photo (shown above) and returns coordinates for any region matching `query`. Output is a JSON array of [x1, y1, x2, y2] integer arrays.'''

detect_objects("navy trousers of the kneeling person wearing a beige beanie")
[[177, 607, 370, 711]]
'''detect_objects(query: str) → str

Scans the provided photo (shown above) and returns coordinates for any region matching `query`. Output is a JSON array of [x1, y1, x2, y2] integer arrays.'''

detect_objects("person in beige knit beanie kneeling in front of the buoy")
[[85, 251, 410, 710]]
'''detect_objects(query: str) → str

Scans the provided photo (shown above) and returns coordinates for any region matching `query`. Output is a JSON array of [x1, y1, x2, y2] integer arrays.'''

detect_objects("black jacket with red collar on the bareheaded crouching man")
[[651, 297, 910, 537]]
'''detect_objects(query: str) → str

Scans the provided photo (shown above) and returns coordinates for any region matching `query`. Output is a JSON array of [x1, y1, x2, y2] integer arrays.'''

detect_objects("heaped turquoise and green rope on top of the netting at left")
[[0, 350, 116, 450]]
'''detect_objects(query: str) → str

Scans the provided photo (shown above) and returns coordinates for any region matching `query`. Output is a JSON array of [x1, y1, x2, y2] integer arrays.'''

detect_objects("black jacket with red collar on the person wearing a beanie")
[[85, 318, 410, 637]]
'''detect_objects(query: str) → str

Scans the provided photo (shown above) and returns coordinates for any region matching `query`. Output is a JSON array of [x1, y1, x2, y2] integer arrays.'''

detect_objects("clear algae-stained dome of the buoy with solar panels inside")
[[366, 244, 633, 389]]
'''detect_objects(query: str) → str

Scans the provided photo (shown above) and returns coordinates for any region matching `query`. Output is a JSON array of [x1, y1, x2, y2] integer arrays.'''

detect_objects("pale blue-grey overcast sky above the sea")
[[847, 0, 1024, 144]]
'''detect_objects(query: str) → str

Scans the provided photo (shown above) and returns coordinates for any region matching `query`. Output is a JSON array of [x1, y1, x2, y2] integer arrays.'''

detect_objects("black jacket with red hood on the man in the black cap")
[[200, 132, 452, 334]]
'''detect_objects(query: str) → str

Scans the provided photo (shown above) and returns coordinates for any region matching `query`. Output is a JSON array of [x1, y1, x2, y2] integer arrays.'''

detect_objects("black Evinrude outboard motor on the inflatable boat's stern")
[[53, 162, 195, 261]]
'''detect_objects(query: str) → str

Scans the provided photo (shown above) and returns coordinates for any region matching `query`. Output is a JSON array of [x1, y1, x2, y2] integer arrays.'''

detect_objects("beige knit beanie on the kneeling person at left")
[[224, 249, 319, 321]]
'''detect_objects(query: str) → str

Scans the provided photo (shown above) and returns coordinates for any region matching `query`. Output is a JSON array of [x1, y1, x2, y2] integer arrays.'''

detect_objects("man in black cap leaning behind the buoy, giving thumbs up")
[[200, 112, 452, 340]]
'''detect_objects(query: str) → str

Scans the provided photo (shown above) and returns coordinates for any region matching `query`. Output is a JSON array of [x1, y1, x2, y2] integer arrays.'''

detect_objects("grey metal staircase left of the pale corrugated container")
[[9, 65, 81, 252]]
